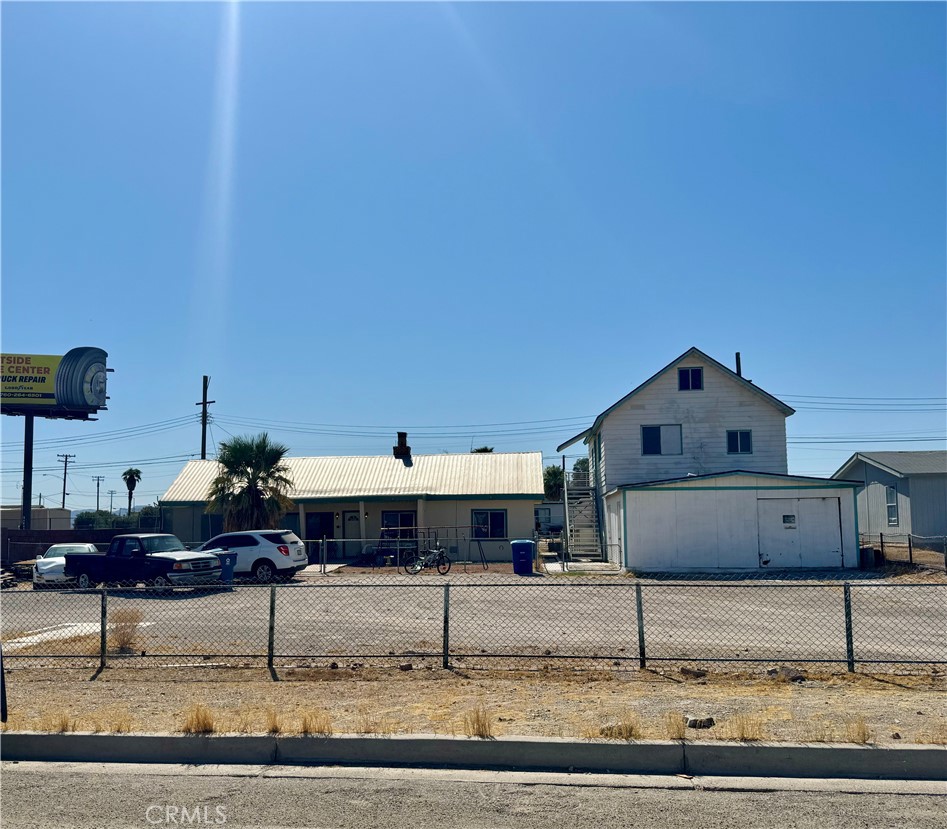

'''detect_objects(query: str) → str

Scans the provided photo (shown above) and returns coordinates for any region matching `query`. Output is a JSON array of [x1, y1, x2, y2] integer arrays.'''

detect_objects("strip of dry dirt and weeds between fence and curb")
[[6, 659, 947, 745]]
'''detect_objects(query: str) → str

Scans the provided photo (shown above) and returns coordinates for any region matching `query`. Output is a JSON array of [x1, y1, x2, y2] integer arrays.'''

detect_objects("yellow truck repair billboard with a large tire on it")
[[0, 347, 108, 418]]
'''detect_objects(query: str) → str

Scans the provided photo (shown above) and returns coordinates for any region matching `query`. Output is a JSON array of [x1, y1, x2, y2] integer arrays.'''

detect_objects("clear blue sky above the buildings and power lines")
[[0, 3, 947, 508]]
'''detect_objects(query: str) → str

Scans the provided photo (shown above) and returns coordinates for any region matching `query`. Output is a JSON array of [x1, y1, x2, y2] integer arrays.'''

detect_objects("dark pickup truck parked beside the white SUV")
[[66, 533, 220, 589]]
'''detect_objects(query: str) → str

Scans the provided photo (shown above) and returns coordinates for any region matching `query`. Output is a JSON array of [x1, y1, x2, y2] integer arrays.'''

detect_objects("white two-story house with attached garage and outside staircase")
[[558, 348, 858, 570]]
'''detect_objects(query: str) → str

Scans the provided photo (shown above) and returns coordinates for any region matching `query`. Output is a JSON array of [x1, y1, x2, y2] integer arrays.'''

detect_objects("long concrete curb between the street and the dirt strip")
[[0, 731, 947, 781]]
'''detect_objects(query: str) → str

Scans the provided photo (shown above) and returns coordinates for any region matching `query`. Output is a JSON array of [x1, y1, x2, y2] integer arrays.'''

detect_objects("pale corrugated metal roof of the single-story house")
[[159, 452, 543, 504]]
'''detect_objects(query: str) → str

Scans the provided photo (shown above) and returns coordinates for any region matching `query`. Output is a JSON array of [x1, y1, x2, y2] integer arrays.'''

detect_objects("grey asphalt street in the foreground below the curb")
[[0, 763, 947, 829]]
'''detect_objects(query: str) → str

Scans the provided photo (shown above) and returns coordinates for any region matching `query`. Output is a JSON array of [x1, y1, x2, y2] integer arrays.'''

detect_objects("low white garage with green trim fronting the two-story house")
[[605, 471, 858, 571]]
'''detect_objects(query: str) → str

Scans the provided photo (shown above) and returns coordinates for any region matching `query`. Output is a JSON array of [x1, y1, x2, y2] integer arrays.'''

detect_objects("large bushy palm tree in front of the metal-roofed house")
[[207, 432, 293, 532]]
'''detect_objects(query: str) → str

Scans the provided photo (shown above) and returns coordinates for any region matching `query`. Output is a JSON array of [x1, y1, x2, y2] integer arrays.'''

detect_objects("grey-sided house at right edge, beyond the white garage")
[[832, 450, 947, 537]]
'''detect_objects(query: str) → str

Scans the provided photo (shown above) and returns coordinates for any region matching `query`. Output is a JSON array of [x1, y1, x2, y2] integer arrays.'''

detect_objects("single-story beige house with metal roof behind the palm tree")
[[159, 446, 543, 560]]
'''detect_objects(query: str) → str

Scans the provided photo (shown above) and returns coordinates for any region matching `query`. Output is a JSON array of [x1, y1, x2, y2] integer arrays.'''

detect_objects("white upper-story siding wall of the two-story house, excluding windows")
[[593, 358, 788, 489]]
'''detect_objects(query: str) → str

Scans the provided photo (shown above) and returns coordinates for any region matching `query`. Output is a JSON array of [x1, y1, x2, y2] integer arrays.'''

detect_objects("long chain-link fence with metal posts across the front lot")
[[0, 576, 947, 671]]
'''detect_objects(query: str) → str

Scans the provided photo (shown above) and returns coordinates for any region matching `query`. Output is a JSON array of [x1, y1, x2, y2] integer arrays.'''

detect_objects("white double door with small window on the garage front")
[[756, 498, 842, 569]]
